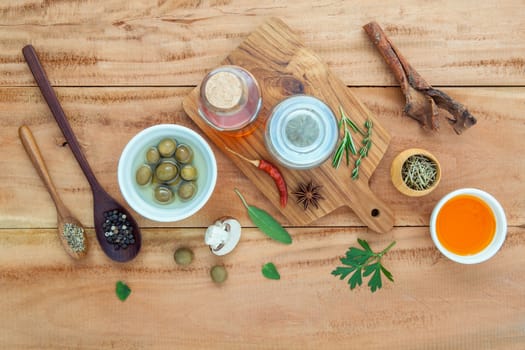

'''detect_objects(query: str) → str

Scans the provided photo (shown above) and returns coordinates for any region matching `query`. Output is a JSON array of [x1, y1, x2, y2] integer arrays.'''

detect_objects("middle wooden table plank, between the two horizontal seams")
[[0, 87, 525, 228]]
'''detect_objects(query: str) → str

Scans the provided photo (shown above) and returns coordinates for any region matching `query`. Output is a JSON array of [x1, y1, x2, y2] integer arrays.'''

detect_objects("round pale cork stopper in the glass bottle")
[[204, 72, 243, 110]]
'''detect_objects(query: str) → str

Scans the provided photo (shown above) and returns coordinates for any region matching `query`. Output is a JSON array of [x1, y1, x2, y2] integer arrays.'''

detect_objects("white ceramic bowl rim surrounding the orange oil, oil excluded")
[[430, 188, 507, 264]]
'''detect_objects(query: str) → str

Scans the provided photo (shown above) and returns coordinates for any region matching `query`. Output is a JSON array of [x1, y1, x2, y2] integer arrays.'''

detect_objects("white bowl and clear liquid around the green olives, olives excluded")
[[118, 124, 217, 222]]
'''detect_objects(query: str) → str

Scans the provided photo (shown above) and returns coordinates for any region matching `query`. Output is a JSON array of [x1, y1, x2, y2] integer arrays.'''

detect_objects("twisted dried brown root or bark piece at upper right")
[[363, 22, 476, 134]]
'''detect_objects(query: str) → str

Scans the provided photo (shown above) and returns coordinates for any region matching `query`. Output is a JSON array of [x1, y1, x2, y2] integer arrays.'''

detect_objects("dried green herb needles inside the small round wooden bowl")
[[401, 154, 437, 191]]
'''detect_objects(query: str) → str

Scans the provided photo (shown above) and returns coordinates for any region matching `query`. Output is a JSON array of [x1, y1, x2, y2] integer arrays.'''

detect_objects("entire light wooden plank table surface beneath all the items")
[[0, 0, 525, 349]]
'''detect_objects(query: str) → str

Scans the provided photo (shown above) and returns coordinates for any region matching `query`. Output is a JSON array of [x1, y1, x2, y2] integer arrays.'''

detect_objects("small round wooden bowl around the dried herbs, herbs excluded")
[[390, 148, 441, 197]]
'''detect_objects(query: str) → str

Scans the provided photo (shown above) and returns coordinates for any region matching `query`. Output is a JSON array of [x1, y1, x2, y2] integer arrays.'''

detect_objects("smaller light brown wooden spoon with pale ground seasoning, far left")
[[18, 125, 87, 259]]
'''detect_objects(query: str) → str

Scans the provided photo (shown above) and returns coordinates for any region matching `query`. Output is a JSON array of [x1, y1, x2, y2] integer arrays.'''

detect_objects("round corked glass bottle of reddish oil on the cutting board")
[[199, 66, 262, 136]]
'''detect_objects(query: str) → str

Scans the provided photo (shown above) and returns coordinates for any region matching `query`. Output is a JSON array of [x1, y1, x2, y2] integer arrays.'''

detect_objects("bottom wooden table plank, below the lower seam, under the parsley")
[[0, 227, 525, 350]]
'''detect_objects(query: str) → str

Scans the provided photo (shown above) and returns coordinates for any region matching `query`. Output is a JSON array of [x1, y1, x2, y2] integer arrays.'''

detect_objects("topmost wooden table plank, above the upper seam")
[[0, 0, 525, 86]]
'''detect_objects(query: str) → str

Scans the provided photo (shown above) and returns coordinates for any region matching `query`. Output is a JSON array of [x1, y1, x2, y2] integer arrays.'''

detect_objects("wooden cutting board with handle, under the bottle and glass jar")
[[183, 18, 394, 232]]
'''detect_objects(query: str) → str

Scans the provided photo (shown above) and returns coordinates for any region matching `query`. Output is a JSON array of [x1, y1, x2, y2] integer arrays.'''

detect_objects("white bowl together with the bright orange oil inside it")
[[430, 188, 507, 264]]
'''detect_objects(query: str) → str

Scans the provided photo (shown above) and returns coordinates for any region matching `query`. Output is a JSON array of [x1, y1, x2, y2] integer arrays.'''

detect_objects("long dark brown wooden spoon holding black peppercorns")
[[22, 45, 142, 262]]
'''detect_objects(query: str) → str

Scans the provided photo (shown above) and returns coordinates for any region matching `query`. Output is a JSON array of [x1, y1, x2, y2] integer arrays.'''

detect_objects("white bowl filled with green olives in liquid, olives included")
[[118, 124, 217, 222]]
